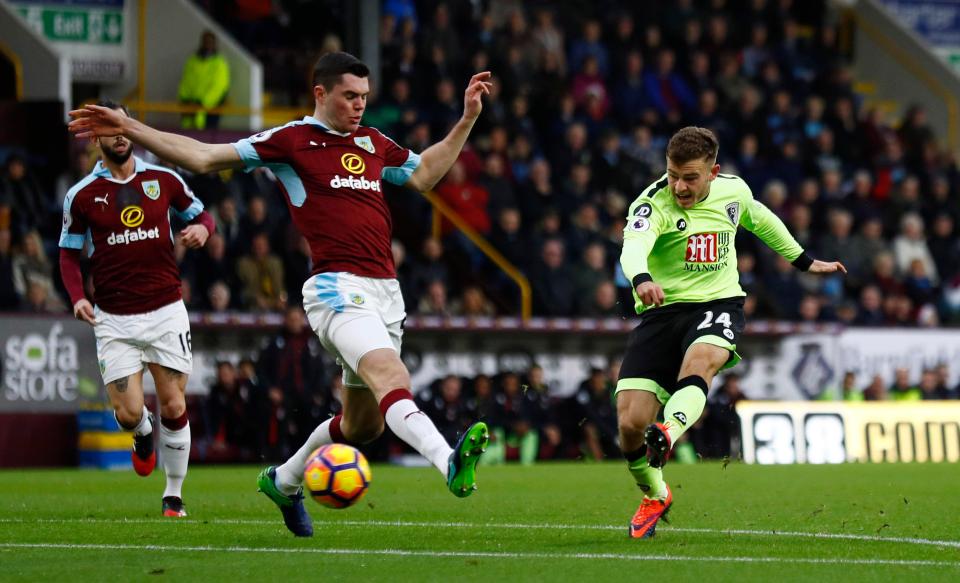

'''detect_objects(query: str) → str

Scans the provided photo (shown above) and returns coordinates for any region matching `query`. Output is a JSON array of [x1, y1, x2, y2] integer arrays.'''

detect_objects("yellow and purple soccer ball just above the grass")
[[303, 443, 373, 508]]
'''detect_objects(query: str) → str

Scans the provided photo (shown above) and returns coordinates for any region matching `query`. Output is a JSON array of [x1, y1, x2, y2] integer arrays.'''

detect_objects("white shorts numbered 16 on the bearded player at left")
[[93, 300, 193, 384]]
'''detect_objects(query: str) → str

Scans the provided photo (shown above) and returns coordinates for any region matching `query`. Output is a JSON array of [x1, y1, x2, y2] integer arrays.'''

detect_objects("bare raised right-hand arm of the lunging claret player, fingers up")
[[406, 71, 490, 192]]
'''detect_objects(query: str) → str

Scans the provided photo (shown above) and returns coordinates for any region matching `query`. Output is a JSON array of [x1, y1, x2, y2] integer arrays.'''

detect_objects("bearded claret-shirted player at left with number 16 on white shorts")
[[60, 101, 214, 516]]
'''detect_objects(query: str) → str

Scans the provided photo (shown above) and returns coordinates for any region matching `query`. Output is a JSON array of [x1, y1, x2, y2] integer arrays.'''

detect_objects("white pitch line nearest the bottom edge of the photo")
[[0, 543, 960, 568]]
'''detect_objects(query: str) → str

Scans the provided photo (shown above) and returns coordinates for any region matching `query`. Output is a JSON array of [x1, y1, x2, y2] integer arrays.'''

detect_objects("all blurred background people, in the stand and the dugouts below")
[[0, 0, 960, 461]]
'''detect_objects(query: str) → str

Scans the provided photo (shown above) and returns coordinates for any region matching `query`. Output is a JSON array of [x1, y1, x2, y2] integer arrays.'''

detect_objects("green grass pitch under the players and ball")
[[0, 463, 960, 583]]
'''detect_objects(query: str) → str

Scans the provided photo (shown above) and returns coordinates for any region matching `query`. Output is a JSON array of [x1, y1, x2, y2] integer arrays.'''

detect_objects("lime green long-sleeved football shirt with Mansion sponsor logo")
[[620, 174, 803, 314]]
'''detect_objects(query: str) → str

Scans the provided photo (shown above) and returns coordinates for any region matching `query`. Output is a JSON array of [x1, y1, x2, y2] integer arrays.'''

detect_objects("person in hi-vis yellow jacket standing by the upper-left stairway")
[[179, 30, 230, 130]]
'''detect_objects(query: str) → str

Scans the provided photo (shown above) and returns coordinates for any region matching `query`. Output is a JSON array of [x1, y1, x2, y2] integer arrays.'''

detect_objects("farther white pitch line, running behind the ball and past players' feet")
[[0, 518, 960, 549]]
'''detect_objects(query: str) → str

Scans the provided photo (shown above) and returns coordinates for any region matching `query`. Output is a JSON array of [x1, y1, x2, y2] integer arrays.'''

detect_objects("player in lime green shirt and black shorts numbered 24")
[[616, 127, 846, 538]]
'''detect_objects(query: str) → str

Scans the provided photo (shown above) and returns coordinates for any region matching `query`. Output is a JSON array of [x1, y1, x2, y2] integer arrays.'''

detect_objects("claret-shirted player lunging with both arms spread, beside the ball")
[[70, 53, 490, 536]]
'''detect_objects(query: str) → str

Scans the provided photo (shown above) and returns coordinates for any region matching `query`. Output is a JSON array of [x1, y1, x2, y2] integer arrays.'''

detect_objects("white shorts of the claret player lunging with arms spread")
[[303, 272, 407, 388]]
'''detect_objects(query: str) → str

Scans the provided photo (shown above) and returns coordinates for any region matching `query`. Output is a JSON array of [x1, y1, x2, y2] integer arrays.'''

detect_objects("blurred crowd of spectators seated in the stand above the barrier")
[[0, 0, 960, 326]]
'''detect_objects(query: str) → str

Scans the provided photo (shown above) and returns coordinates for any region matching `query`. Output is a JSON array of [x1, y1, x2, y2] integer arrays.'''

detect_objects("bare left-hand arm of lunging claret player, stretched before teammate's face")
[[69, 105, 243, 174]]
